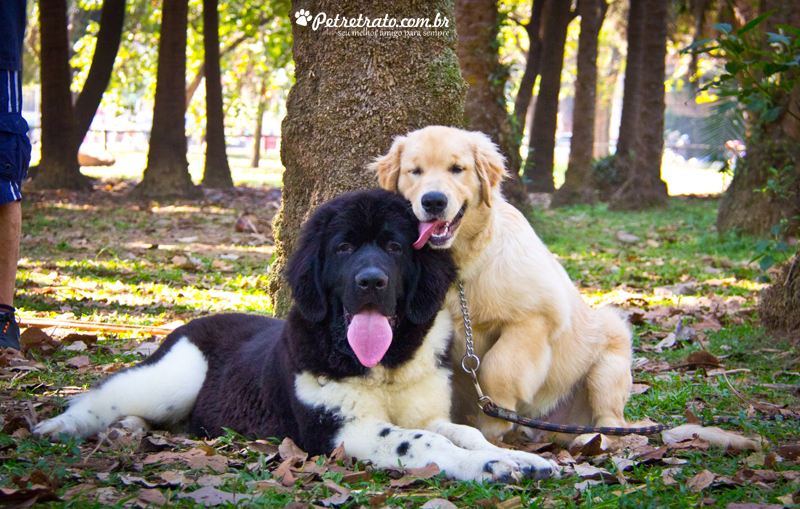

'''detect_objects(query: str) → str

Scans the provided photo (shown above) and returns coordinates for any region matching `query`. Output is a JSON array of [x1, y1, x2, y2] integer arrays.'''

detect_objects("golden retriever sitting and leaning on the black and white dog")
[[370, 126, 632, 441]]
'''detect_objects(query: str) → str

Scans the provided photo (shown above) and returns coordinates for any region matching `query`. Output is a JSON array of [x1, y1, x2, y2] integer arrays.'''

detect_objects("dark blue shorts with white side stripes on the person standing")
[[0, 69, 31, 205]]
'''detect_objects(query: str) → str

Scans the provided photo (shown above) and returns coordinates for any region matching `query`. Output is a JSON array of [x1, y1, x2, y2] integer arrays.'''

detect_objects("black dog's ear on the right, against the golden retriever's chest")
[[406, 245, 457, 324]]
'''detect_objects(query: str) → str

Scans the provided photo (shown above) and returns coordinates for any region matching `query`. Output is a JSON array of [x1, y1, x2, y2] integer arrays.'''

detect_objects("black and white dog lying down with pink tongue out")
[[34, 190, 557, 482]]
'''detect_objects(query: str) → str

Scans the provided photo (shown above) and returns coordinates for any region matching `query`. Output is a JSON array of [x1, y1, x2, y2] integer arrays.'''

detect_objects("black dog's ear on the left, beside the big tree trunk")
[[286, 210, 330, 322]]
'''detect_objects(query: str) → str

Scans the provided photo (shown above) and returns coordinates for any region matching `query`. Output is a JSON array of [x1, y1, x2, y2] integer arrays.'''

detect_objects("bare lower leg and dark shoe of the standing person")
[[0, 196, 22, 348]]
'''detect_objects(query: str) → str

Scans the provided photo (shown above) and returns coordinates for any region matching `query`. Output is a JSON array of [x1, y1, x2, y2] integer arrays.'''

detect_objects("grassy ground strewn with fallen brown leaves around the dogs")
[[0, 184, 800, 509]]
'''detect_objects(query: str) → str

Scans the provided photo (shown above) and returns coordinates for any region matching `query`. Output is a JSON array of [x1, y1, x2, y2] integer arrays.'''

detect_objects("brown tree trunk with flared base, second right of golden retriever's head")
[[551, 0, 608, 207]]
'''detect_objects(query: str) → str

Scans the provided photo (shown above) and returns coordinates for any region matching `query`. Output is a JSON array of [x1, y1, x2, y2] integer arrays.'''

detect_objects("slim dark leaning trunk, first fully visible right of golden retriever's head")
[[524, 1, 575, 193]]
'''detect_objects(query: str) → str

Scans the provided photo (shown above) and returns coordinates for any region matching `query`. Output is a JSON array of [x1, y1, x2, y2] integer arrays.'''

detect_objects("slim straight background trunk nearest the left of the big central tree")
[[202, 0, 233, 189]]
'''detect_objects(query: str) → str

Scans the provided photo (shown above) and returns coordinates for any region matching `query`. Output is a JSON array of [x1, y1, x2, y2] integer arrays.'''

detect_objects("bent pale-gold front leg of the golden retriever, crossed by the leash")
[[477, 315, 552, 439]]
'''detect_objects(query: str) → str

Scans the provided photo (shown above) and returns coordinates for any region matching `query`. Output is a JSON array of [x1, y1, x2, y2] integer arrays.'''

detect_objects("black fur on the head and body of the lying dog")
[[144, 190, 456, 454]]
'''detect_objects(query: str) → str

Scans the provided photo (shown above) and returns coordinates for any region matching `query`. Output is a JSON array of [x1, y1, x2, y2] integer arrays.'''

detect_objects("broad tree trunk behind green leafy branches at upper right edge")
[[717, 0, 800, 237]]
